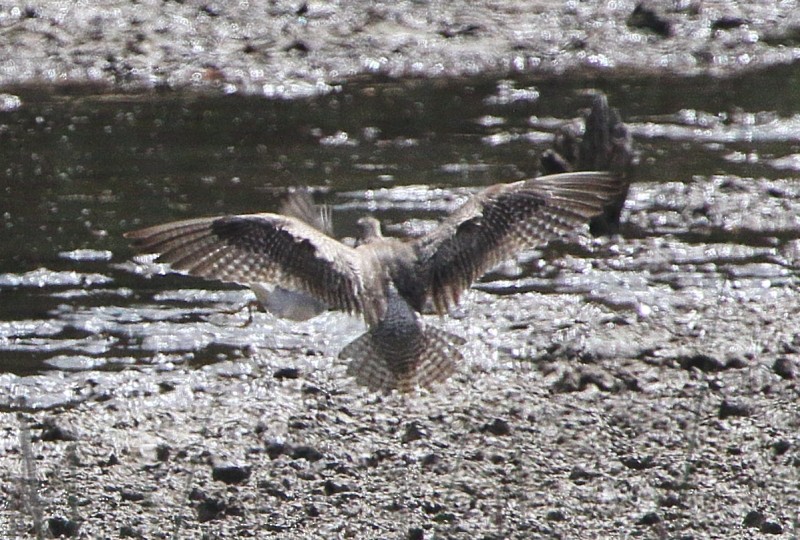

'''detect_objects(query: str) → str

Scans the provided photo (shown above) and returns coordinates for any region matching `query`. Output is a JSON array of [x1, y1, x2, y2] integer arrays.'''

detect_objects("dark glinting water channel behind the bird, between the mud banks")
[[0, 66, 800, 382]]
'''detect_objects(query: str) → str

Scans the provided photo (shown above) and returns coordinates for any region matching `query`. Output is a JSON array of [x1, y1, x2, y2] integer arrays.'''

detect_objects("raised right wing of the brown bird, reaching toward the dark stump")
[[415, 172, 623, 314]]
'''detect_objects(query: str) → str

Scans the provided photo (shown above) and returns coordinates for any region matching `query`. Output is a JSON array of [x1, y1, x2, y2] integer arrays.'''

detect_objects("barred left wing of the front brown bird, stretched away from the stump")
[[125, 214, 382, 320]]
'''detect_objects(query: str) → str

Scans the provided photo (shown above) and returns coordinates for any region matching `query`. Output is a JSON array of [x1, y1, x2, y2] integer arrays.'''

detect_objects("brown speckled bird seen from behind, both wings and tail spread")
[[125, 172, 623, 393]]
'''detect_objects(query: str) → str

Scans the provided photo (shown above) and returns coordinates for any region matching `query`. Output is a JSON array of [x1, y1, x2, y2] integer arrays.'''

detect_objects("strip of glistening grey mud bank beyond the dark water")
[[0, 0, 800, 98]]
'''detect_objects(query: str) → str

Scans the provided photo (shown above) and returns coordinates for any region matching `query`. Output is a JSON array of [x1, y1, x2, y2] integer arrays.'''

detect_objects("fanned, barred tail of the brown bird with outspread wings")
[[339, 326, 466, 393]]
